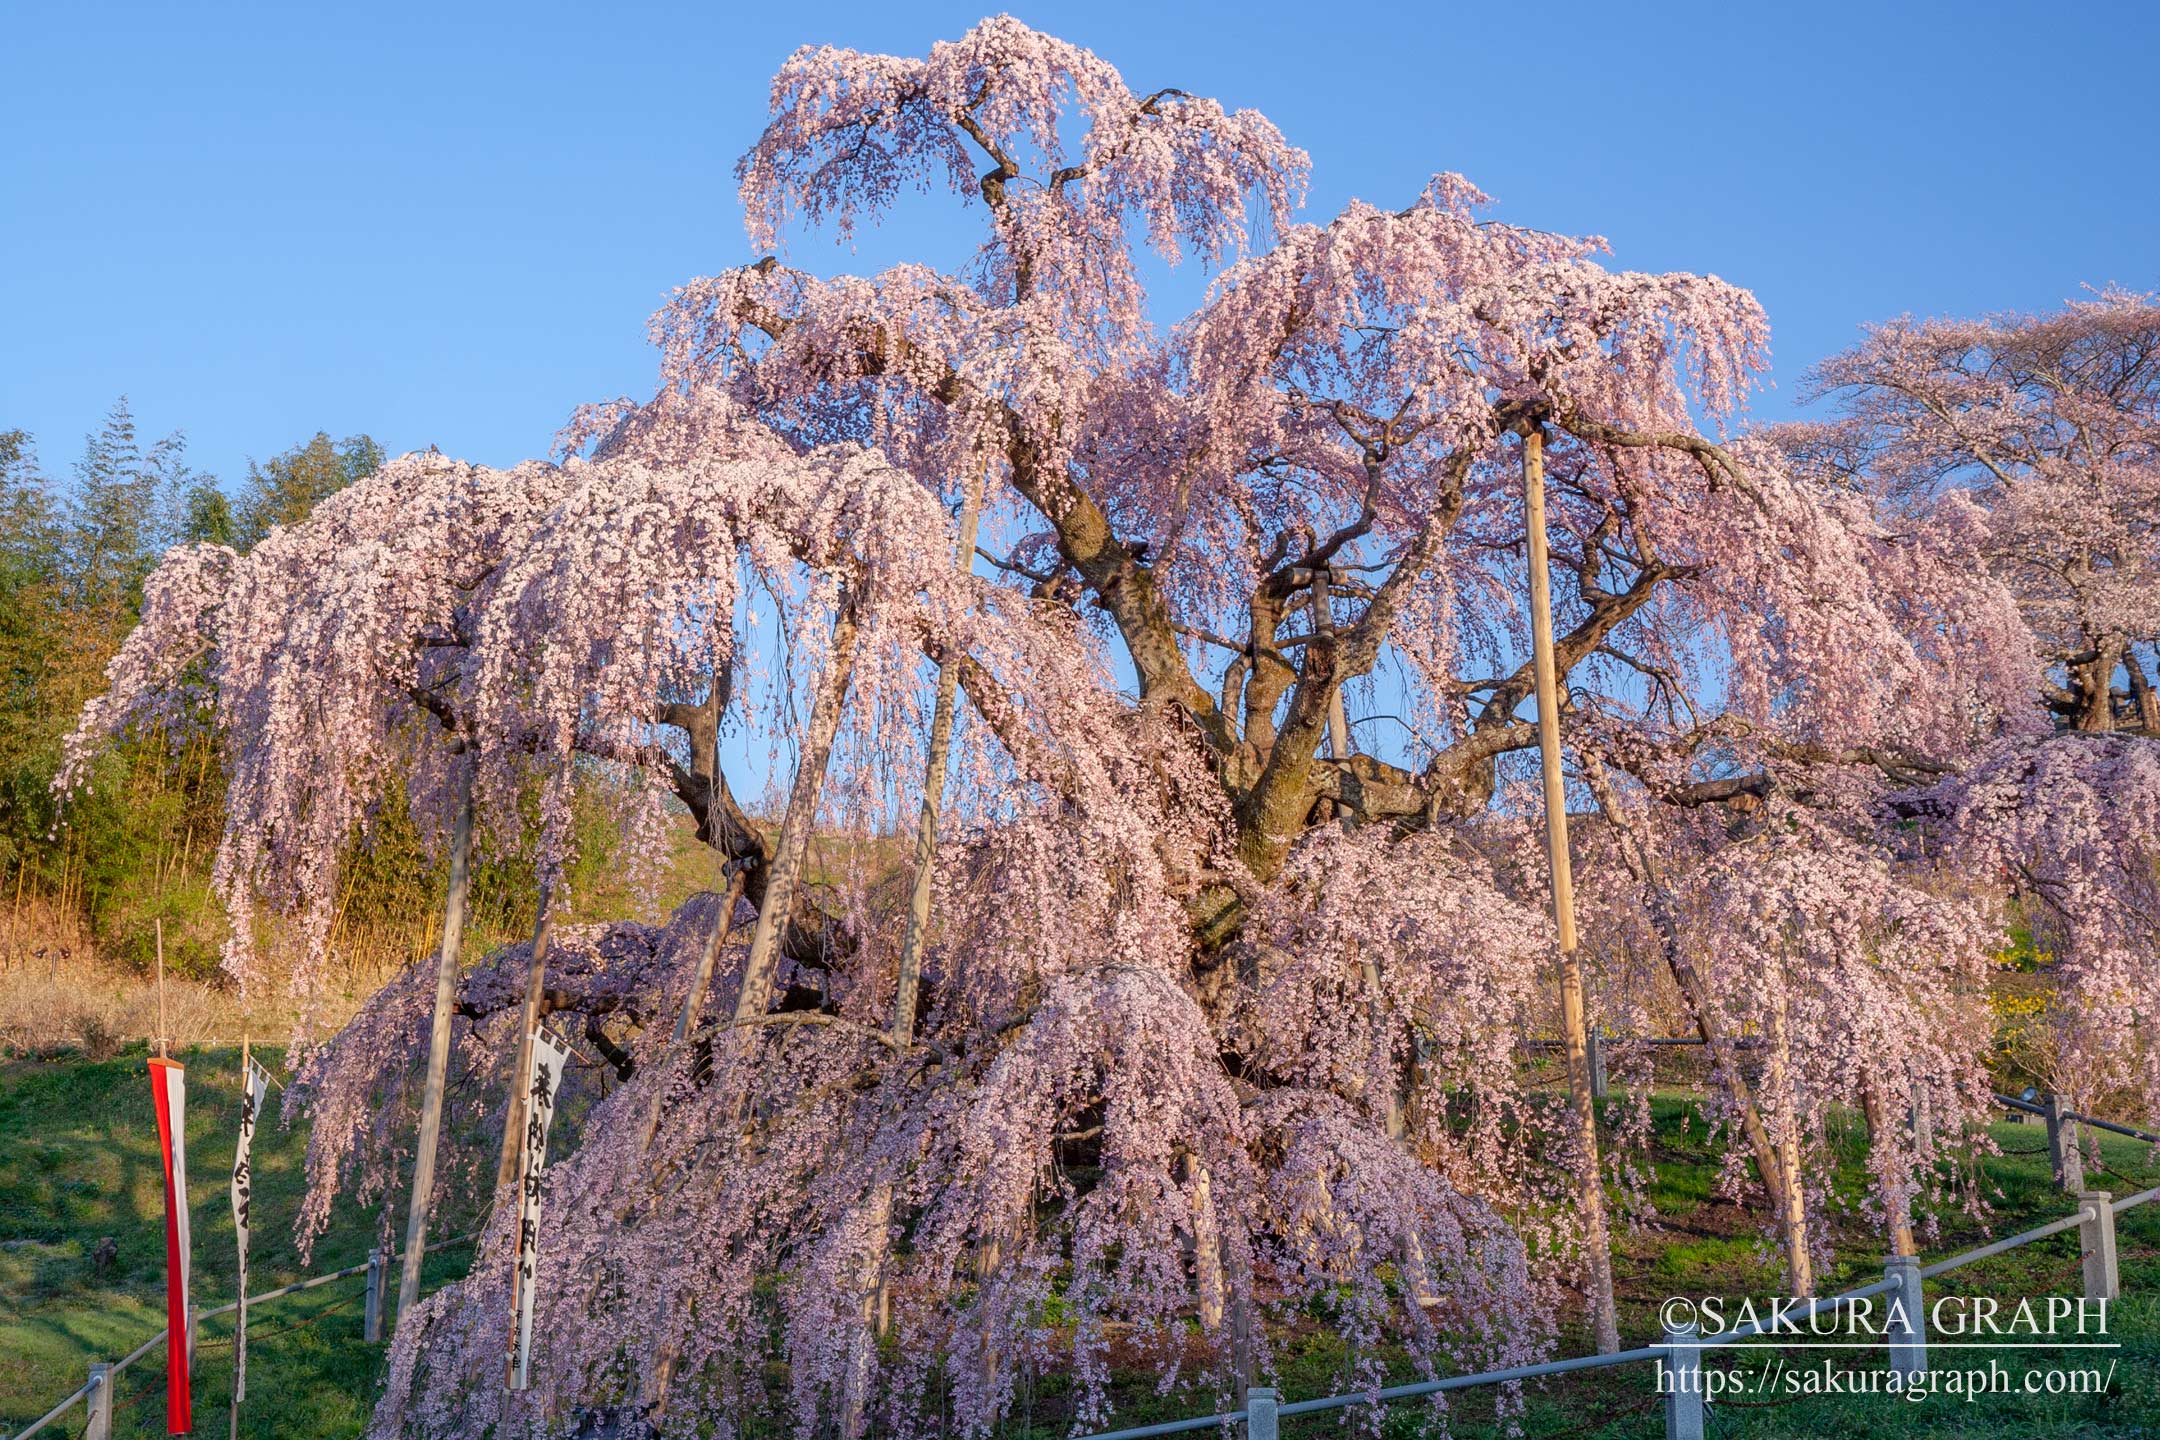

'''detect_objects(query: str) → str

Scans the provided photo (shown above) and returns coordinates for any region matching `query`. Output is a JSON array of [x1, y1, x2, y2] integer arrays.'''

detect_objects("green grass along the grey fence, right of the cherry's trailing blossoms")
[[1019, 1095, 2160, 1440]]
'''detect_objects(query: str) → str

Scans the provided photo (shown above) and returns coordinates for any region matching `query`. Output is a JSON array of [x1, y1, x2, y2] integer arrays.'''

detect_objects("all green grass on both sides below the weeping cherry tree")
[[0, 1049, 2160, 1440]]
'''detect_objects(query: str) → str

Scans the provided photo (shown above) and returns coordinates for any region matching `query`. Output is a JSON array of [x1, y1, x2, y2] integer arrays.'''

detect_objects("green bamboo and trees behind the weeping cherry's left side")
[[0, 399, 416, 974]]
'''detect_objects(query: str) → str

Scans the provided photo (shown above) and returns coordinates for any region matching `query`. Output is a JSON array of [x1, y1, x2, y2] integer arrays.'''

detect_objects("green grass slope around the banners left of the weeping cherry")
[[0, 1047, 467, 1438]]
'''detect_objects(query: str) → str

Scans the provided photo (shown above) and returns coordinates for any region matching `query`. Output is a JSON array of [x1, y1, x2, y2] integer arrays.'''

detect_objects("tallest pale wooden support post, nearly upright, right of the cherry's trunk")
[[1523, 425, 1620, 1356]]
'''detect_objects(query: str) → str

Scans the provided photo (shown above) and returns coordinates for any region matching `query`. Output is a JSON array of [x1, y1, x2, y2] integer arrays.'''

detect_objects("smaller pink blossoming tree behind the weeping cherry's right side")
[[1780, 289, 2160, 736]]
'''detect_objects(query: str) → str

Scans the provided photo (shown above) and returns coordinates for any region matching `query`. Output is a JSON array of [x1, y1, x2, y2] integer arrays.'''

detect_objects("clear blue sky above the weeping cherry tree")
[[0, 0, 2160, 481]]
